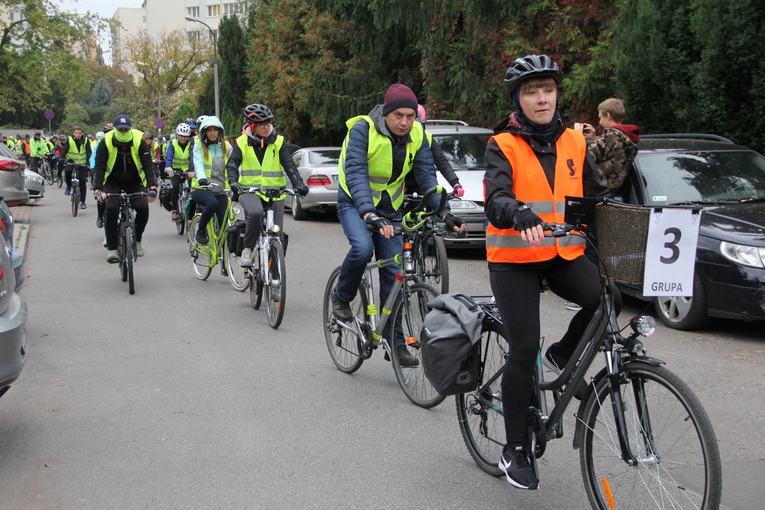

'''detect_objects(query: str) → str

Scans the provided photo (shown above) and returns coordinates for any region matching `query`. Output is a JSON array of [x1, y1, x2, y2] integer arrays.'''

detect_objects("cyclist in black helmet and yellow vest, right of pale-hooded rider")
[[226, 103, 308, 267]]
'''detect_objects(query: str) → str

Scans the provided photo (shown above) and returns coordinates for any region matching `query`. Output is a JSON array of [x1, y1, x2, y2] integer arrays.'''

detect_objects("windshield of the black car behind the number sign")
[[635, 151, 765, 205]]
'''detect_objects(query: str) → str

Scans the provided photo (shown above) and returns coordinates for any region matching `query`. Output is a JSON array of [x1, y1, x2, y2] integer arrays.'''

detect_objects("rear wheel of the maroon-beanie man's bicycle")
[[321, 267, 368, 374]]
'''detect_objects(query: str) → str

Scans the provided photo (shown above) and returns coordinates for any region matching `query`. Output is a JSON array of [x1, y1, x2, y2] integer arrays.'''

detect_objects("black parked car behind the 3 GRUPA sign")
[[621, 134, 765, 330]]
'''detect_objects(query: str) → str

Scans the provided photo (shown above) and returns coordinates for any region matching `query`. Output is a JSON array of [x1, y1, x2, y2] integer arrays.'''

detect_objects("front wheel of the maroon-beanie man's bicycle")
[[390, 283, 446, 409]]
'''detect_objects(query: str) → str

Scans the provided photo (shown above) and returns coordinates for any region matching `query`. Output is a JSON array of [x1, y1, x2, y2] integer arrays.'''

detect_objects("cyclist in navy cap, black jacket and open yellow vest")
[[93, 115, 157, 263]]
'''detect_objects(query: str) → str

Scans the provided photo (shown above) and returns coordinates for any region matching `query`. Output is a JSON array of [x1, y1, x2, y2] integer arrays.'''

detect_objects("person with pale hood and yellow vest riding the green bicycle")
[[191, 115, 231, 244]]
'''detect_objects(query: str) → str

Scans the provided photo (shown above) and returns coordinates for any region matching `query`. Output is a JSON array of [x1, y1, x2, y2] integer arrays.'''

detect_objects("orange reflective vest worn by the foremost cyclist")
[[486, 129, 587, 264]]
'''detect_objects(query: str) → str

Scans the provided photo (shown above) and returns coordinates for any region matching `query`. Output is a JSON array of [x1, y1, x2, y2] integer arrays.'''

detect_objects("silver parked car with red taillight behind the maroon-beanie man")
[[285, 147, 342, 220]]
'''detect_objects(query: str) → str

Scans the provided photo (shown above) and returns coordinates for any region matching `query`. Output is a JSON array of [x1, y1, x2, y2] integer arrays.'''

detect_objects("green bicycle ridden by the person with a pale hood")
[[188, 183, 250, 292]]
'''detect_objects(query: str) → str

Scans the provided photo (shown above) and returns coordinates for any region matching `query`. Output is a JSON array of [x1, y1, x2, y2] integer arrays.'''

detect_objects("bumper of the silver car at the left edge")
[[0, 293, 27, 390]]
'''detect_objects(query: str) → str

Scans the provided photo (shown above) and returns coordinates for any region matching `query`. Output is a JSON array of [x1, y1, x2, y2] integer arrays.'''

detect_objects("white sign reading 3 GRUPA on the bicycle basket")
[[643, 208, 701, 296]]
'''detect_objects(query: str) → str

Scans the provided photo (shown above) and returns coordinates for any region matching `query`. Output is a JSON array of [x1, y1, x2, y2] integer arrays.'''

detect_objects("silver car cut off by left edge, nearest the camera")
[[0, 229, 27, 396]]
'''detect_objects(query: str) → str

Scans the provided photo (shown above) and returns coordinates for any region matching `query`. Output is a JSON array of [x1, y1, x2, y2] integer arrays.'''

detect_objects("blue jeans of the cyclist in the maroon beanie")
[[335, 201, 406, 345]]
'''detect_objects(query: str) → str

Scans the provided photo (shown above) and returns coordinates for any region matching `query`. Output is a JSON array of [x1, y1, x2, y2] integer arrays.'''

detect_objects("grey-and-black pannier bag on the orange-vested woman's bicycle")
[[420, 293, 484, 396]]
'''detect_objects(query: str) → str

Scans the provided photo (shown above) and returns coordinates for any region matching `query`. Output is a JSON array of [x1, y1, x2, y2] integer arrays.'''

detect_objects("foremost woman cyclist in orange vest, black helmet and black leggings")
[[484, 55, 621, 489]]
